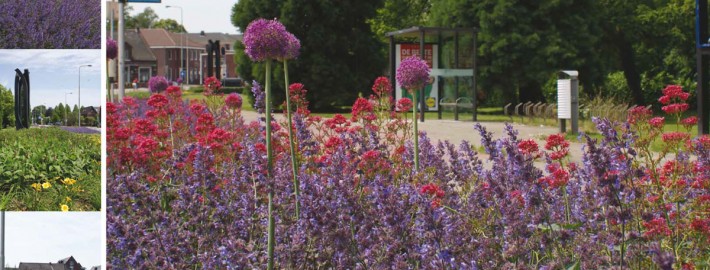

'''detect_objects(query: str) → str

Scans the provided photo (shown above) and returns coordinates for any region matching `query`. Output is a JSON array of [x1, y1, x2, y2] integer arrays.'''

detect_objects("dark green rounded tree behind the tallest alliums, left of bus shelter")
[[232, 0, 386, 110]]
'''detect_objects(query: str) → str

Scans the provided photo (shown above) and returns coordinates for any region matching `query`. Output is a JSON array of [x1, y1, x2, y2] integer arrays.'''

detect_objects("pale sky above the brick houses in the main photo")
[[124, 0, 238, 34]]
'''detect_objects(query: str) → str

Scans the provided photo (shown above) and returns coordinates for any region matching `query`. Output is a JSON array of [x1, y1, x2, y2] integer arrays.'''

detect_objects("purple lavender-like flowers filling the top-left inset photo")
[[0, 0, 101, 49]]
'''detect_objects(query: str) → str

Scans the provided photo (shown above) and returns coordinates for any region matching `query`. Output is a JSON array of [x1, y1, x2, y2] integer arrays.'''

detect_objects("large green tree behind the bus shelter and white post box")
[[429, 0, 604, 105]]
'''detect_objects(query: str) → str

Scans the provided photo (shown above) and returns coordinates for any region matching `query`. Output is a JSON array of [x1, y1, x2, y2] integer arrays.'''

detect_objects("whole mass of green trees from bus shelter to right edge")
[[426, 0, 695, 105]]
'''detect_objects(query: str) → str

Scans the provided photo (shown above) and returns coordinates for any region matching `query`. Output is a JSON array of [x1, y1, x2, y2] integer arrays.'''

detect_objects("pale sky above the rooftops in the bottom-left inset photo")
[[5, 212, 101, 269]]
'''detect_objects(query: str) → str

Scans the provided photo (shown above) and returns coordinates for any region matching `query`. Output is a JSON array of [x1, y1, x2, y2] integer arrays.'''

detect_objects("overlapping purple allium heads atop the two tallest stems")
[[242, 19, 290, 62]]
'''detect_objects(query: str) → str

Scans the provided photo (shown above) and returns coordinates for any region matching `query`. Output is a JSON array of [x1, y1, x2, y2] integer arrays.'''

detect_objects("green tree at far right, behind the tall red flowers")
[[599, 0, 695, 104]]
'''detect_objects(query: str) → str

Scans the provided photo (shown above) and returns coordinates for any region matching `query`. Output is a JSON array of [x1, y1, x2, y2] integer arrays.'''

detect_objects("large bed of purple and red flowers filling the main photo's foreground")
[[106, 79, 710, 269]]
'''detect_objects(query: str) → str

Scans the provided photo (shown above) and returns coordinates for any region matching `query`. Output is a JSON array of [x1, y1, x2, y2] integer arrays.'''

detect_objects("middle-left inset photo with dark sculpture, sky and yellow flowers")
[[0, 50, 101, 211]]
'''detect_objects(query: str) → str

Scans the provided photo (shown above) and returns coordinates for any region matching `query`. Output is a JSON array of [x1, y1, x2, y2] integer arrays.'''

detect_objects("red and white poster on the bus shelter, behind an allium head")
[[395, 43, 439, 111]]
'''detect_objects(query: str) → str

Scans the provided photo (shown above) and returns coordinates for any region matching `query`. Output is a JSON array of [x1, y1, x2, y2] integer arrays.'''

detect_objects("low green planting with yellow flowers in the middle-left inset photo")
[[0, 128, 101, 211]]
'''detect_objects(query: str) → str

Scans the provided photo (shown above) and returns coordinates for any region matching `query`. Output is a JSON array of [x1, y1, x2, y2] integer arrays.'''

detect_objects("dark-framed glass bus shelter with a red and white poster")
[[386, 26, 478, 122]]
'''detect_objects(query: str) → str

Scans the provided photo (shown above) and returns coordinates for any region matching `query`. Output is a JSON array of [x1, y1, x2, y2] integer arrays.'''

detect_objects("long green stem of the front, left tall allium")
[[264, 60, 275, 270]]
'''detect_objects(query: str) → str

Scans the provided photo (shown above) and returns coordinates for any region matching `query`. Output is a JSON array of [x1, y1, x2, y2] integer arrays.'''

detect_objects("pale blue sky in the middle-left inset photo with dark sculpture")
[[0, 50, 102, 107]]
